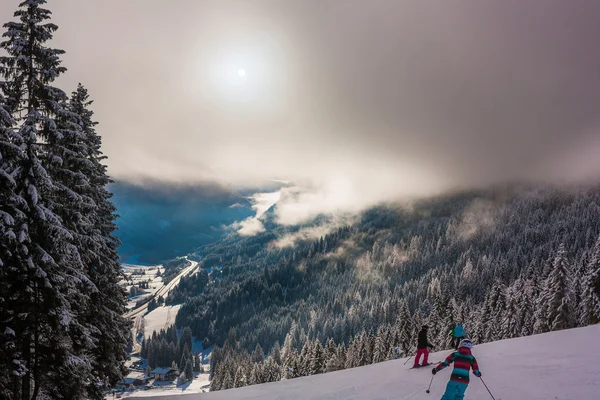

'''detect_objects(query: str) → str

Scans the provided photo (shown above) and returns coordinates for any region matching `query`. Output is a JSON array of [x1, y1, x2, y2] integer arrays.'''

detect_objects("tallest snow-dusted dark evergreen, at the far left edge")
[[0, 0, 98, 399]]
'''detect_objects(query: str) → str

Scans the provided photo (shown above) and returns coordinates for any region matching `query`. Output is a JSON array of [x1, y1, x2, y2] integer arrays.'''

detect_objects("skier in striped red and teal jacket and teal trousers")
[[431, 339, 481, 400]]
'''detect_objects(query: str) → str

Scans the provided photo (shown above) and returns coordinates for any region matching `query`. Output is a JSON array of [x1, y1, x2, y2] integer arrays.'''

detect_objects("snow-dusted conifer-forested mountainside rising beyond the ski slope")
[[144, 187, 600, 389]]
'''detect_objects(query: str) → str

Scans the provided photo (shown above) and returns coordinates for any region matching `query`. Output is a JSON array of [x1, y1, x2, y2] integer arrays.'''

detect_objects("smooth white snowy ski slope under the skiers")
[[141, 325, 600, 400]]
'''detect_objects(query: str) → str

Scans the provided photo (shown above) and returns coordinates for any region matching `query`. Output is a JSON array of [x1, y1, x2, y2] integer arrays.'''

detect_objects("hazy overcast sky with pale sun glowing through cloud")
[[0, 0, 600, 220]]
